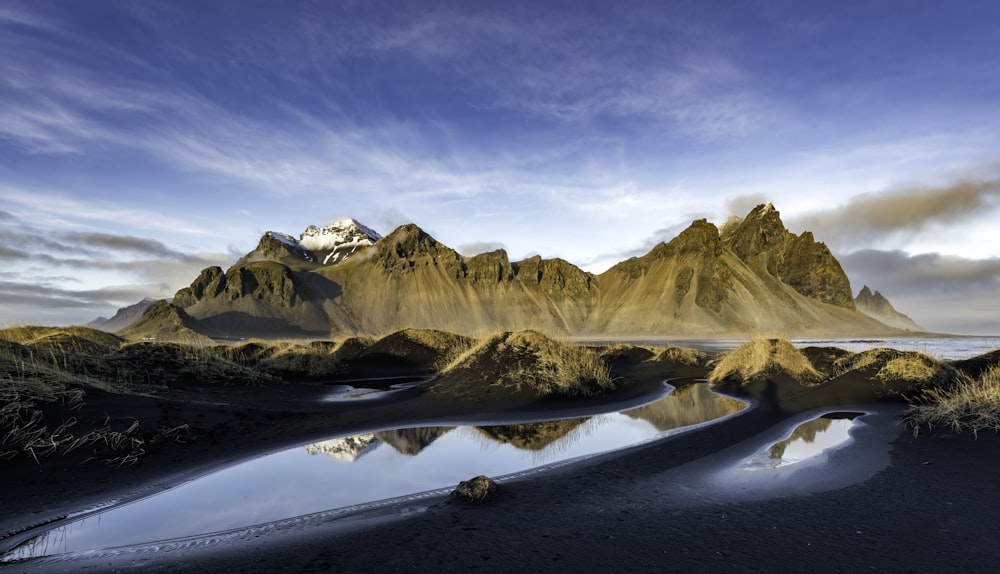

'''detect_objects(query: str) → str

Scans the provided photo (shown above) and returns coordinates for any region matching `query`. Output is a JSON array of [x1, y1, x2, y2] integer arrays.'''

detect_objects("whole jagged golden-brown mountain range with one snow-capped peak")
[[122, 208, 915, 338]]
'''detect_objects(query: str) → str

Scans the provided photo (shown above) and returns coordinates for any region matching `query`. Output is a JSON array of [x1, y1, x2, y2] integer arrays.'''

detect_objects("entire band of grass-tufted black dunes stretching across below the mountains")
[[0, 327, 1000, 476]]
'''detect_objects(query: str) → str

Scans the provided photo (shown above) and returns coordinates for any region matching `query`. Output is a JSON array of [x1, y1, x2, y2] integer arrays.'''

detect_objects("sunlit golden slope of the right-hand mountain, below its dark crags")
[[594, 219, 886, 335]]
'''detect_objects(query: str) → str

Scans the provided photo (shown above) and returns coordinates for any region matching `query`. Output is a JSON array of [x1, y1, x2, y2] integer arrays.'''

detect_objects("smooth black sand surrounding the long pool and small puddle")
[[0, 366, 1000, 572]]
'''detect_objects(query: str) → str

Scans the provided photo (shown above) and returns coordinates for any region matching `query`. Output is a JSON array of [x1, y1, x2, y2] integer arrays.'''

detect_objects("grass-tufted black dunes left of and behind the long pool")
[[0, 327, 656, 465]]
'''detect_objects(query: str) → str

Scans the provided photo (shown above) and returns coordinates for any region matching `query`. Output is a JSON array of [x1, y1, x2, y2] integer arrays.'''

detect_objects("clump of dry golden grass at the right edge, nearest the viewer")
[[905, 365, 1000, 436]]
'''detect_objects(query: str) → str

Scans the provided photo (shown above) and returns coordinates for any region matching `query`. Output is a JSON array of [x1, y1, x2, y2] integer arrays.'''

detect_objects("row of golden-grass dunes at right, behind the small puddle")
[[707, 339, 1000, 434]]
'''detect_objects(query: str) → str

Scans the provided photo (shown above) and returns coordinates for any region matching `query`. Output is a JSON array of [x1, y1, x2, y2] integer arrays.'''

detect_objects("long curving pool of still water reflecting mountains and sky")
[[0, 384, 744, 562]]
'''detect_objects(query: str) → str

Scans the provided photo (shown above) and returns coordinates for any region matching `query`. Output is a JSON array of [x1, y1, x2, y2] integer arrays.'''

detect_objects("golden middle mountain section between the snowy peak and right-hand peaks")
[[321, 225, 593, 333]]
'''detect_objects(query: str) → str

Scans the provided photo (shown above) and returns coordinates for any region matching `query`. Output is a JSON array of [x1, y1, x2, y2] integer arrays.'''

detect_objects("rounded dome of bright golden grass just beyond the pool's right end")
[[708, 339, 823, 384]]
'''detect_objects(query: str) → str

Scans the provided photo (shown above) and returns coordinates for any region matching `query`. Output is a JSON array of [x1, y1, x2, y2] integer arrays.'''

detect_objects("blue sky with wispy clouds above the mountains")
[[0, 0, 1000, 334]]
